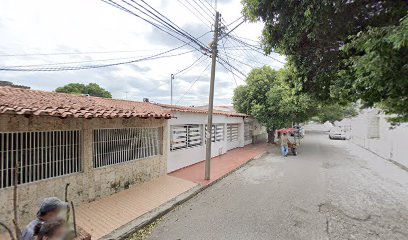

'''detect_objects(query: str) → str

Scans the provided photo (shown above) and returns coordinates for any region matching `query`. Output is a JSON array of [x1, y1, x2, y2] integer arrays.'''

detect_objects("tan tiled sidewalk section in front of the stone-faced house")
[[76, 176, 196, 239]]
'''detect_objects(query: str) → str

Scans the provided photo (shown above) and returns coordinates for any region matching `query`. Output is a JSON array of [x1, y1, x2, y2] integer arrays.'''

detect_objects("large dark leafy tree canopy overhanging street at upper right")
[[243, 0, 408, 119]]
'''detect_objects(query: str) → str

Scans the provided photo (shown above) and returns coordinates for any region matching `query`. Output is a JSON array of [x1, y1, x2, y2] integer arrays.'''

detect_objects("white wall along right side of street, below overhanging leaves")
[[351, 109, 408, 167]]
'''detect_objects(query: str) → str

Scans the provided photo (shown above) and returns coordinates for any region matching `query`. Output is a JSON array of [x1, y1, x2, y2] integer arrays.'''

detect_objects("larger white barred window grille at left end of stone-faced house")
[[0, 130, 82, 188]]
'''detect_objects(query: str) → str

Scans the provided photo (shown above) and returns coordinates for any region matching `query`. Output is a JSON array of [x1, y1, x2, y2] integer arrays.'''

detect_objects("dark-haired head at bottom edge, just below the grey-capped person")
[[34, 218, 66, 240]]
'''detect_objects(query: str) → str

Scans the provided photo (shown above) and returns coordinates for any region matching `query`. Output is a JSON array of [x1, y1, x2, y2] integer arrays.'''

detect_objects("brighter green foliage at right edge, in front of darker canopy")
[[332, 17, 408, 122]]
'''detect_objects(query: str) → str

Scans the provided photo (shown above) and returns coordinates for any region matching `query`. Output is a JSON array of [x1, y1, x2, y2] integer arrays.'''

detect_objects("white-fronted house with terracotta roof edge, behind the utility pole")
[[158, 104, 266, 172]]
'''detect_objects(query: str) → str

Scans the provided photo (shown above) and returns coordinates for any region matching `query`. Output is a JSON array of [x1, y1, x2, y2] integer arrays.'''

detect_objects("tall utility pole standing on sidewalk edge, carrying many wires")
[[204, 11, 220, 180]]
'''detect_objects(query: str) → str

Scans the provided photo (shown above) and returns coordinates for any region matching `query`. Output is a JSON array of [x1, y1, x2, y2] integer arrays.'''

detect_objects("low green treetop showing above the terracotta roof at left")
[[55, 83, 112, 98]]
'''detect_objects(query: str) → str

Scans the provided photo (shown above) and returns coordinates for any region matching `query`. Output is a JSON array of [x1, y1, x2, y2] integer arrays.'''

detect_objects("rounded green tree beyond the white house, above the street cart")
[[233, 66, 314, 142]]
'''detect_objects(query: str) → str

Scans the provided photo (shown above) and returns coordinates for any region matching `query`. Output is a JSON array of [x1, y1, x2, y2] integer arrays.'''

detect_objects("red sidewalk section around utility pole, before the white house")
[[169, 143, 267, 186]]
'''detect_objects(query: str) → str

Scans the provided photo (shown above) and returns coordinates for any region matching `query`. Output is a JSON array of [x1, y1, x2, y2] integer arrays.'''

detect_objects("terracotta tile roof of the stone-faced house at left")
[[0, 87, 171, 118]]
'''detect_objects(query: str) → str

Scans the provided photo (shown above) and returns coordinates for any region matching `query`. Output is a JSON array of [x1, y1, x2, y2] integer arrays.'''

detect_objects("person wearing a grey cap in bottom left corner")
[[21, 197, 68, 240]]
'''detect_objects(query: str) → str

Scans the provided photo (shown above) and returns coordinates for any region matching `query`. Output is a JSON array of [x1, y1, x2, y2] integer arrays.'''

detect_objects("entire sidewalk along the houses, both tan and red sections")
[[76, 144, 267, 239]]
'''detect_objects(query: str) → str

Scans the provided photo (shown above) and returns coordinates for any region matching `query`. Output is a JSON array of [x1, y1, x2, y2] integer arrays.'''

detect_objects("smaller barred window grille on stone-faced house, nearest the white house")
[[93, 128, 162, 168]]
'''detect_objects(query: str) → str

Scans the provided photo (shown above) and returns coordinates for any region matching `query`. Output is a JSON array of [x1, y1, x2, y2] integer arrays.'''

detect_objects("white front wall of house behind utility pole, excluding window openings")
[[167, 112, 244, 172]]
